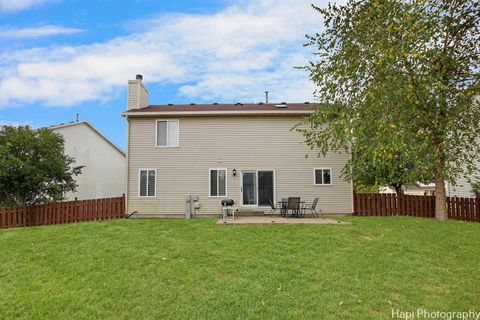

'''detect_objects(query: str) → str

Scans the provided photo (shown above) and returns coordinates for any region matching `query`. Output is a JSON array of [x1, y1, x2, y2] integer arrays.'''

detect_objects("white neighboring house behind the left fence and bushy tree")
[[50, 121, 126, 199]]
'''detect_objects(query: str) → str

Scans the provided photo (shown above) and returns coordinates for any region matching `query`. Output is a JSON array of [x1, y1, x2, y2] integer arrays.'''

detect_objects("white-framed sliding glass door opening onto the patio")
[[242, 170, 275, 207]]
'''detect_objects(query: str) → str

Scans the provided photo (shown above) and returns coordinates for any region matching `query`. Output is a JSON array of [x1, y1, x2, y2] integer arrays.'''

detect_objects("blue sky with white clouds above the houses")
[[0, 0, 332, 147]]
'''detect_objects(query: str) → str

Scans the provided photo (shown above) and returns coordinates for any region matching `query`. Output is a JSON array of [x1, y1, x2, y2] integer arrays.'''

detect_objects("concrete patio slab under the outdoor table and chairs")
[[217, 216, 349, 224]]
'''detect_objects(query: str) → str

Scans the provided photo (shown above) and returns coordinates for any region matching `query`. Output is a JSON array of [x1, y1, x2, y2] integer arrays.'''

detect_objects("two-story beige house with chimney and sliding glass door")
[[122, 75, 353, 217]]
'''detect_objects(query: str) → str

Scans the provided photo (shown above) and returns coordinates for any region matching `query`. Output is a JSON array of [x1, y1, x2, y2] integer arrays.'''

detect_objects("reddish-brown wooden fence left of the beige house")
[[0, 195, 125, 229]]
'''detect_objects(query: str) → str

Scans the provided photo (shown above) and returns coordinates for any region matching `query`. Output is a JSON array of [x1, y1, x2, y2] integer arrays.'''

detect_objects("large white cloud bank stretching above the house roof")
[[0, 0, 338, 107]]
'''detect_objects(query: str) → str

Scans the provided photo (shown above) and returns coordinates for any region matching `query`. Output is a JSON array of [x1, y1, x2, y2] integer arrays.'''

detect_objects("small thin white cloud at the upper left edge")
[[0, 25, 85, 39]]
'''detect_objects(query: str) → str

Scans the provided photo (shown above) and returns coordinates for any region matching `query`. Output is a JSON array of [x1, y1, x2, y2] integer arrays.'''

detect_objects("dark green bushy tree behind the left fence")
[[0, 126, 82, 206]]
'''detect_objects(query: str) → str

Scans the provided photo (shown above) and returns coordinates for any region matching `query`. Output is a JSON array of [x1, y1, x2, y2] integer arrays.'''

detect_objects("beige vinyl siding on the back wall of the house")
[[128, 116, 352, 215]]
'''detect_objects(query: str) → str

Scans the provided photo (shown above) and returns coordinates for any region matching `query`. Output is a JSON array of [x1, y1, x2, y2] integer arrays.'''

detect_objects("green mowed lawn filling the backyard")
[[0, 217, 480, 319]]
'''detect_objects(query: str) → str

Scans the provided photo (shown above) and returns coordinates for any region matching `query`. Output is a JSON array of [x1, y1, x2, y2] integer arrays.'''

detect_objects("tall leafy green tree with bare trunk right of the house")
[[298, 0, 480, 220]]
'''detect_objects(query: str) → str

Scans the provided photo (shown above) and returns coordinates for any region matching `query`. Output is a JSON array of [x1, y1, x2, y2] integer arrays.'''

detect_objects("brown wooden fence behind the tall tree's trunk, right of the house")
[[353, 193, 480, 222]]
